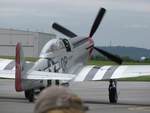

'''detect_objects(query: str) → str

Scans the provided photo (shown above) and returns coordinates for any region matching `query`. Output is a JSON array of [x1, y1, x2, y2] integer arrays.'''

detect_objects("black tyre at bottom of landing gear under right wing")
[[109, 87, 118, 103]]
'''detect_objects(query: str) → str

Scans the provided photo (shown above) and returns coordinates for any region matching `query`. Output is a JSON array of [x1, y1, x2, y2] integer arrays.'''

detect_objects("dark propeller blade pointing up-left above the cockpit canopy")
[[52, 23, 77, 38]]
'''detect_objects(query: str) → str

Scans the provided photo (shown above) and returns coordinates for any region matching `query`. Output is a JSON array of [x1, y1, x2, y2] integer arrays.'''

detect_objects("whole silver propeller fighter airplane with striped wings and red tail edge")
[[0, 8, 150, 103]]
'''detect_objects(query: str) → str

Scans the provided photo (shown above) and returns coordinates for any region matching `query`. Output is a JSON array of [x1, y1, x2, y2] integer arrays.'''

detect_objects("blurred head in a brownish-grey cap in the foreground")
[[34, 86, 84, 113]]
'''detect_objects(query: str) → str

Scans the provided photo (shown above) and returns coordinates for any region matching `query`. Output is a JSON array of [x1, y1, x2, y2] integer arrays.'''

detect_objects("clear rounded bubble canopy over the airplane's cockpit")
[[41, 39, 65, 54]]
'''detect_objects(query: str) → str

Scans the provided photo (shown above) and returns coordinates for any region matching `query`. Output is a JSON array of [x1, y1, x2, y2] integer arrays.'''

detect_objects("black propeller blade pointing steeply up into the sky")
[[89, 8, 106, 37]]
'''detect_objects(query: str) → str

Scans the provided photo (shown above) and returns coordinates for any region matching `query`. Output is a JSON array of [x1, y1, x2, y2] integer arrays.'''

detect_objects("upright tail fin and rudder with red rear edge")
[[15, 43, 25, 92]]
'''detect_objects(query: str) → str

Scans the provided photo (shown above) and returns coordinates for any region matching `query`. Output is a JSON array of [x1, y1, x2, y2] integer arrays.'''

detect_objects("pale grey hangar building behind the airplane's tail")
[[0, 28, 56, 57]]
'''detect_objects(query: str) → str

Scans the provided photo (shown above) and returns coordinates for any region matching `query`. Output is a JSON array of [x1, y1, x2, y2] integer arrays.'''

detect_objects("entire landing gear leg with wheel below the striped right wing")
[[108, 79, 118, 103]]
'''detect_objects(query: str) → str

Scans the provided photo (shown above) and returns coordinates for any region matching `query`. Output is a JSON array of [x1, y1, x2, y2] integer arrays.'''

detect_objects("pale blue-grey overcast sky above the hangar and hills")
[[0, 0, 150, 49]]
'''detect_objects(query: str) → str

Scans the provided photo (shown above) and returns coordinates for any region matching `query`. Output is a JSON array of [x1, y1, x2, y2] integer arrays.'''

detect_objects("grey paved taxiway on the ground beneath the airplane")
[[0, 79, 150, 113]]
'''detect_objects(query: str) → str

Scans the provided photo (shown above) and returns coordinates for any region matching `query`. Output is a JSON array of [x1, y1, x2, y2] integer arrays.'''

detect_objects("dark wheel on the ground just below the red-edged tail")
[[24, 89, 34, 102]]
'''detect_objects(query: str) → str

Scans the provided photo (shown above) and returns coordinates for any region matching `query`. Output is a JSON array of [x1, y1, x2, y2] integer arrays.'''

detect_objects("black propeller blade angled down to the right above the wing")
[[94, 47, 123, 65]]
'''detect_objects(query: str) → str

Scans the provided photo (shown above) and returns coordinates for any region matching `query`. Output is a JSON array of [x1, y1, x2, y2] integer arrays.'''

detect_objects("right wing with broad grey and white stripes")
[[74, 65, 150, 81]]
